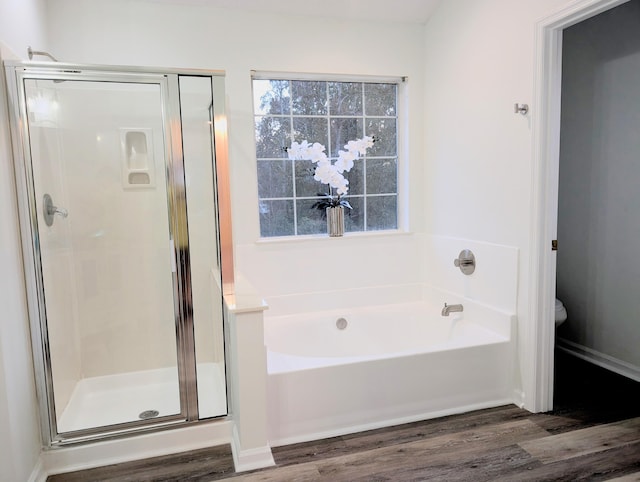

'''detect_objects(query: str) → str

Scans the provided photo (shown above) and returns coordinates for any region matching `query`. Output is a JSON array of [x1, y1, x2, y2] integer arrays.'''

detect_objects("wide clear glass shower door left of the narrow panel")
[[22, 70, 194, 440]]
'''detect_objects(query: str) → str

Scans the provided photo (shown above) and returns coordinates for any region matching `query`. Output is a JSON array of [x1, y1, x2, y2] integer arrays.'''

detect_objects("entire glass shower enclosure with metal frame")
[[6, 63, 227, 446]]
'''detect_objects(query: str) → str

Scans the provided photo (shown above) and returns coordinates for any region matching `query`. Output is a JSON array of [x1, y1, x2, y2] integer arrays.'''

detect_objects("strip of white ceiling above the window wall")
[[164, 0, 442, 24]]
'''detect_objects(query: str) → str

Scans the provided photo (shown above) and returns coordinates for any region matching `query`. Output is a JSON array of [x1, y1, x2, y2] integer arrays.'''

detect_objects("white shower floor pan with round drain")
[[58, 363, 227, 433]]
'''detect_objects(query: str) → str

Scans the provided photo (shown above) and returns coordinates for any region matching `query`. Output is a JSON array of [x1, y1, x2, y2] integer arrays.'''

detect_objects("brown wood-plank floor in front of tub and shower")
[[47, 352, 640, 482]]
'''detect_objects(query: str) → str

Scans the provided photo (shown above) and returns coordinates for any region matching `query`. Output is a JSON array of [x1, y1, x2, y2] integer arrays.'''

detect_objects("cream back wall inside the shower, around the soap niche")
[[62, 85, 176, 377]]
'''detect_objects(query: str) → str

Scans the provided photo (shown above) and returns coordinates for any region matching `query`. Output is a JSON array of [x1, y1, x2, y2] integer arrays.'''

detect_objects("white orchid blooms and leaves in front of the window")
[[286, 136, 375, 209]]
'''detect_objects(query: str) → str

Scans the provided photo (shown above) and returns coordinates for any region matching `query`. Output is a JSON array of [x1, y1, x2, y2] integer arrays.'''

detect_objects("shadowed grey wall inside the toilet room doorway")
[[557, 0, 640, 374]]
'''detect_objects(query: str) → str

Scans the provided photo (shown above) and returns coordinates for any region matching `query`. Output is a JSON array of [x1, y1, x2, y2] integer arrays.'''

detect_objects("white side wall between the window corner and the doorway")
[[423, 0, 572, 406]]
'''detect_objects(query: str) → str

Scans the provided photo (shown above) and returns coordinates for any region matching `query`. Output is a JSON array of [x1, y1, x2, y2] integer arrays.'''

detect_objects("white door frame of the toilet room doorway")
[[523, 0, 629, 412]]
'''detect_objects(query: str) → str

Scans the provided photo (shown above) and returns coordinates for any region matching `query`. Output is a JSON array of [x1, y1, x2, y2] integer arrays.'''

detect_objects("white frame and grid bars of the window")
[[251, 70, 408, 238]]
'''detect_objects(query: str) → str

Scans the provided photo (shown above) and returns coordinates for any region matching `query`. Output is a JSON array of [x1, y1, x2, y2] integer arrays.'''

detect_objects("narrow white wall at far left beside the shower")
[[0, 0, 46, 481]]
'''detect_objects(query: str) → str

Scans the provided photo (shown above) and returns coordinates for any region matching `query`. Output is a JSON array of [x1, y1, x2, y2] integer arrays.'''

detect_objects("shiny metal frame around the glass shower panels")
[[5, 62, 233, 448]]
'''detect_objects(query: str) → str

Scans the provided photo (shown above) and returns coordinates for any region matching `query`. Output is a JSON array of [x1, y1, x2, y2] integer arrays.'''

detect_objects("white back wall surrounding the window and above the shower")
[[48, 0, 424, 302]]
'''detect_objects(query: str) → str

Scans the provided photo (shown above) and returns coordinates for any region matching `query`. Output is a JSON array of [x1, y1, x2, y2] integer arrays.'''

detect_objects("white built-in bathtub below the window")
[[265, 301, 515, 446]]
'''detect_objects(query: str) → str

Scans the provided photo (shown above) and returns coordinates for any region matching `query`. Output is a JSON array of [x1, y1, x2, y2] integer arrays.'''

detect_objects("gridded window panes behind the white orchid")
[[253, 77, 398, 237]]
